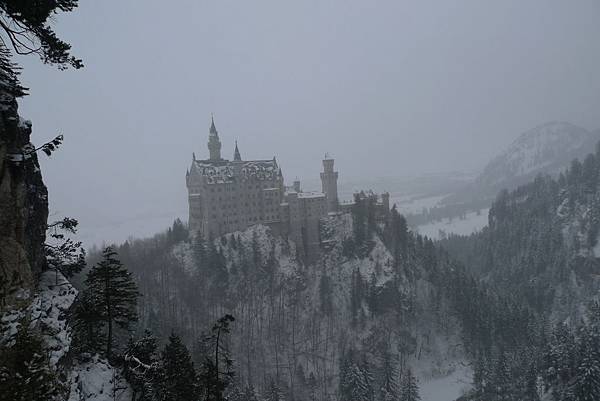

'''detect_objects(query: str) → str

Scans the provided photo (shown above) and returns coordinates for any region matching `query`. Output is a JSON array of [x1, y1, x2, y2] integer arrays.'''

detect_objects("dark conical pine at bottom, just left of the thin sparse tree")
[[157, 333, 200, 401]]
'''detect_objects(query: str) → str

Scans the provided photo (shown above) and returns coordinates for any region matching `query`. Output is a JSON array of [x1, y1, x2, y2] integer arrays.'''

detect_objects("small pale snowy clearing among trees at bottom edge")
[[419, 367, 471, 401]]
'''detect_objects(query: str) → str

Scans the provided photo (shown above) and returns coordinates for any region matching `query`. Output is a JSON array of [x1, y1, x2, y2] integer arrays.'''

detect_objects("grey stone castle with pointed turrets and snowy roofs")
[[186, 119, 340, 260]]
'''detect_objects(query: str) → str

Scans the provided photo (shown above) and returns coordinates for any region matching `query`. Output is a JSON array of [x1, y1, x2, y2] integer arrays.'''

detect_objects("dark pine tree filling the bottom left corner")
[[0, 319, 61, 401]]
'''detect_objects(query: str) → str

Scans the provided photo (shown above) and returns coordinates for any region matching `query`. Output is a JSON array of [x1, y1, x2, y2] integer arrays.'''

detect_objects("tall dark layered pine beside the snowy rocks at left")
[[85, 247, 139, 358]]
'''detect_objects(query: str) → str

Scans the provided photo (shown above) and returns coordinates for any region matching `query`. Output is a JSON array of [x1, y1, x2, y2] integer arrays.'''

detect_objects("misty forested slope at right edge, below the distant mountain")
[[442, 141, 600, 319]]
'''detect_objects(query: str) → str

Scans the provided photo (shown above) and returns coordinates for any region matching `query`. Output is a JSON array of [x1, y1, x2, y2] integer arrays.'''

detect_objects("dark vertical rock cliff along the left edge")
[[0, 86, 48, 310]]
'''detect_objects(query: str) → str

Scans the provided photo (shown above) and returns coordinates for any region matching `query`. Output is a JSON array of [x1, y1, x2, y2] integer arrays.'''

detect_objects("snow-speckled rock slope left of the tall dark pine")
[[30, 271, 77, 367]]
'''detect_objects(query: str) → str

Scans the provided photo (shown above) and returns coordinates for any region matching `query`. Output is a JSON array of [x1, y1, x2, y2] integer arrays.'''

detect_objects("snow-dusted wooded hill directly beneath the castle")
[[110, 205, 469, 400]]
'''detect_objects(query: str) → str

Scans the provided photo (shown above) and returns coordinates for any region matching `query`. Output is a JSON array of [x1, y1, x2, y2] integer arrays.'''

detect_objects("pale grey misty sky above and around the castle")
[[12, 0, 600, 245]]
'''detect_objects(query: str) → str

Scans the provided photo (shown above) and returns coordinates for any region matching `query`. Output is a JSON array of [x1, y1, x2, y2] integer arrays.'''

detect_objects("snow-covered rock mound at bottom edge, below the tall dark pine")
[[68, 355, 131, 401]]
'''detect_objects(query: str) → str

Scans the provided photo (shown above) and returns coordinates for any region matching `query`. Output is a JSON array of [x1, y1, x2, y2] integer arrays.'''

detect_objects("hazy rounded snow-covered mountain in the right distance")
[[444, 122, 600, 204]]
